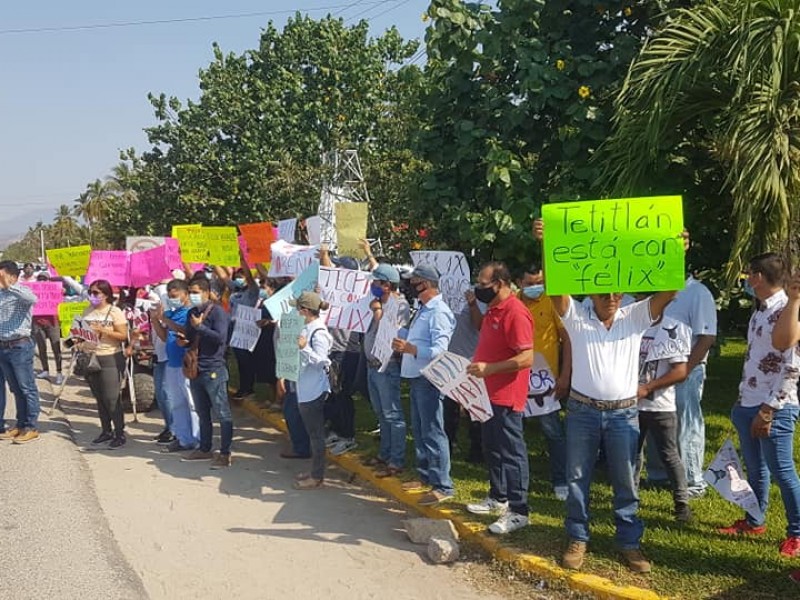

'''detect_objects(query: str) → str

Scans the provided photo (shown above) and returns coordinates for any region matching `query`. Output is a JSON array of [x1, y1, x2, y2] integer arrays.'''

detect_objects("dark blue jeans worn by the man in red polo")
[[481, 404, 530, 515]]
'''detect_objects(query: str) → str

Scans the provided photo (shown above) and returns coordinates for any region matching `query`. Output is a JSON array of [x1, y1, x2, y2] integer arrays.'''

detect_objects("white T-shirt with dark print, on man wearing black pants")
[[639, 317, 692, 412]]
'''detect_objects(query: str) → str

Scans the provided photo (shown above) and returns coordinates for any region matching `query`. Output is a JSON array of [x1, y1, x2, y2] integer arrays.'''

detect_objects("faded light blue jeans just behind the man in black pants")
[[646, 364, 707, 496]]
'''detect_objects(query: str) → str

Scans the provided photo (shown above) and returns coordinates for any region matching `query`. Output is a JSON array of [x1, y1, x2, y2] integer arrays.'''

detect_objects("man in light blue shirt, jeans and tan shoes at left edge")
[[0, 260, 39, 444]]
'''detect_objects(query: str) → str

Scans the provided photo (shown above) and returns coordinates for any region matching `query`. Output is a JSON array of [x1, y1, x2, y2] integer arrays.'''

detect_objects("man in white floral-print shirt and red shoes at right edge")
[[719, 252, 800, 557]]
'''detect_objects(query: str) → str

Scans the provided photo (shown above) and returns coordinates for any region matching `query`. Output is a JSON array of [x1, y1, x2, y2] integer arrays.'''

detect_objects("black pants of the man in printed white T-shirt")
[[634, 410, 689, 510]]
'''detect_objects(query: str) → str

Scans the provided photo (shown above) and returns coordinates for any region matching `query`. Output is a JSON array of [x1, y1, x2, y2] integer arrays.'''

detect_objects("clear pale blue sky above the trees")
[[0, 0, 428, 247]]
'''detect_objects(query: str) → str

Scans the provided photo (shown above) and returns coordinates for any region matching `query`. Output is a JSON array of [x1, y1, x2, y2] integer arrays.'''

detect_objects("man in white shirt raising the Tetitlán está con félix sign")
[[534, 219, 675, 573]]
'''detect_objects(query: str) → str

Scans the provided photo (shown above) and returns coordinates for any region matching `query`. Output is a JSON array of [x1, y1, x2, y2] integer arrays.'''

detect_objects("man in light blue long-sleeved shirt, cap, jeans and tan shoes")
[[392, 264, 456, 506]]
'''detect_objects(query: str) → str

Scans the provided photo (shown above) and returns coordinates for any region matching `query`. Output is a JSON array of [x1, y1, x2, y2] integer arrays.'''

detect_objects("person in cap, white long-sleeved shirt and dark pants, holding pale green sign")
[[292, 292, 333, 490]]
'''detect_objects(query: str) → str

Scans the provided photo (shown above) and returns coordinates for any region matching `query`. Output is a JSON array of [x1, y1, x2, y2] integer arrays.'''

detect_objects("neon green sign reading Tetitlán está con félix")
[[542, 196, 686, 295]]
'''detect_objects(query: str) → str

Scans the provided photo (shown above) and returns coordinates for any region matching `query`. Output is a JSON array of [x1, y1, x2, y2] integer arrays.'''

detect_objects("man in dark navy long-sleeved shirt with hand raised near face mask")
[[183, 278, 233, 469]]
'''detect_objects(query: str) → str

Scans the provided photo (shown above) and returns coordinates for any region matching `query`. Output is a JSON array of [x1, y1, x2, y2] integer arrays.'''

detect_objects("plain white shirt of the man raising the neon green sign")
[[561, 298, 652, 400]]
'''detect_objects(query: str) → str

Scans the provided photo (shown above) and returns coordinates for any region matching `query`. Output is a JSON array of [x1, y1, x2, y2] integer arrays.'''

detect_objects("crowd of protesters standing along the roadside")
[[0, 221, 800, 573]]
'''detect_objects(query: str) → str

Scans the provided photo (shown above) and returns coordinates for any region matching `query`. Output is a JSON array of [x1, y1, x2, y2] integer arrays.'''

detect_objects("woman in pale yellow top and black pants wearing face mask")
[[81, 279, 128, 449]]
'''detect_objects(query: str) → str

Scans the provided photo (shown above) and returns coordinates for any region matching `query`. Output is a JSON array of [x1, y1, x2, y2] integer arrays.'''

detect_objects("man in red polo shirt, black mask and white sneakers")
[[467, 262, 533, 534]]
